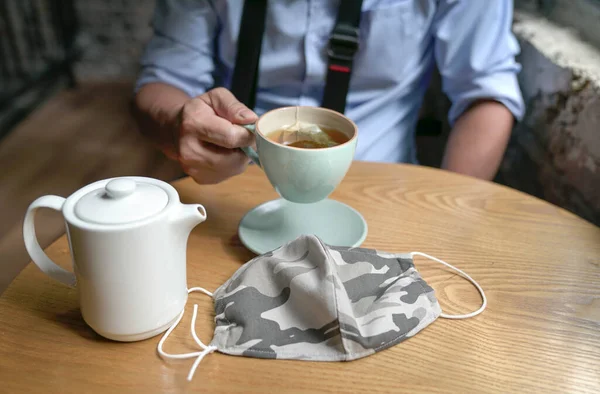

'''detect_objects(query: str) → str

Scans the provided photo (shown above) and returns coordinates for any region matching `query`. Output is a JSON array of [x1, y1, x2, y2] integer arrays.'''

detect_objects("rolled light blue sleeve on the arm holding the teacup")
[[135, 0, 218, 97]]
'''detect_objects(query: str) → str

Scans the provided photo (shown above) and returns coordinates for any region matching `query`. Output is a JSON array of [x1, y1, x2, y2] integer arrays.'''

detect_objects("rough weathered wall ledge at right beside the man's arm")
[[501, 10, 600, 224]]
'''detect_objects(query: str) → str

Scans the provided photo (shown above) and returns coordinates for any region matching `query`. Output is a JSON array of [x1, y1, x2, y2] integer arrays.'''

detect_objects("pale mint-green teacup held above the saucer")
[[242, 107, 358, 204]]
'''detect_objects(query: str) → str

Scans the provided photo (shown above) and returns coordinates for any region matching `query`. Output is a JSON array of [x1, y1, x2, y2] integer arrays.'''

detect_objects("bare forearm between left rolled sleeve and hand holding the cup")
[[133, 83, 190, 159]]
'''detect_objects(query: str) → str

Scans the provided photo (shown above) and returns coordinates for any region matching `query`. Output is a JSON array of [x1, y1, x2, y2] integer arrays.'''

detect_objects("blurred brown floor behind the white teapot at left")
[[0, 82, 181, 294]]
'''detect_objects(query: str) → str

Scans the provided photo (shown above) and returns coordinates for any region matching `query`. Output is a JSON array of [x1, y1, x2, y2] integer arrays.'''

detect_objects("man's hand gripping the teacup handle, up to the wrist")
[[177, 88, 257, 184]]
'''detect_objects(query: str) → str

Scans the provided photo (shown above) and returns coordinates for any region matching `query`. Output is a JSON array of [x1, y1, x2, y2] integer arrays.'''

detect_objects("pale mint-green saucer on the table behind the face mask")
[[238, 199, 367, 254]]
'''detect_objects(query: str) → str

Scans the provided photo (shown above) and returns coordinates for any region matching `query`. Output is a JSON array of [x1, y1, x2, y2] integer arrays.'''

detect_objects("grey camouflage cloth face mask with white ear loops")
[[158, 236, 487, 380]]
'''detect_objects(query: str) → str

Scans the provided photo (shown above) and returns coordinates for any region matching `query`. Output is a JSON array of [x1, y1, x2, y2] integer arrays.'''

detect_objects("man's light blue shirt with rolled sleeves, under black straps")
[[136, 0, 524, 163]]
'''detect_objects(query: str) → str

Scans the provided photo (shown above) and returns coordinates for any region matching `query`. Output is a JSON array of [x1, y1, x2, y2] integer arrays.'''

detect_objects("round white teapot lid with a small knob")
[[75, 177, 169, 224]]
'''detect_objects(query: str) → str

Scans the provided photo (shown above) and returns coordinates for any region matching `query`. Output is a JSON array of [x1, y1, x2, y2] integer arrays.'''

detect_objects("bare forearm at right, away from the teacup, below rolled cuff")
[[442, 100, 514, 180]]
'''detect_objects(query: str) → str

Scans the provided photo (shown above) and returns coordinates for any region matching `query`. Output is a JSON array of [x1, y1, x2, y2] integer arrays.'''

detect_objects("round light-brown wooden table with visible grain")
[[0, 163, 600, 393]]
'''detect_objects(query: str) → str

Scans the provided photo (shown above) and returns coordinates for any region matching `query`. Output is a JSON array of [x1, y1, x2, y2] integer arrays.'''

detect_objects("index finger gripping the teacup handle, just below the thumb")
[[181, 100, 254, 149]]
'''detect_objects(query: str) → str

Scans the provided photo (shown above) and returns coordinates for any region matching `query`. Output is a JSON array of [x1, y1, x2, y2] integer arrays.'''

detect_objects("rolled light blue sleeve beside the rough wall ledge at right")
[[433, 0, 525, 125]]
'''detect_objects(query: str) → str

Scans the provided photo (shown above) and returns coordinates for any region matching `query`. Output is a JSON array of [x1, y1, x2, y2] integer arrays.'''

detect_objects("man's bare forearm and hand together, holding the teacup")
[[134, 83, 257, 184]]
